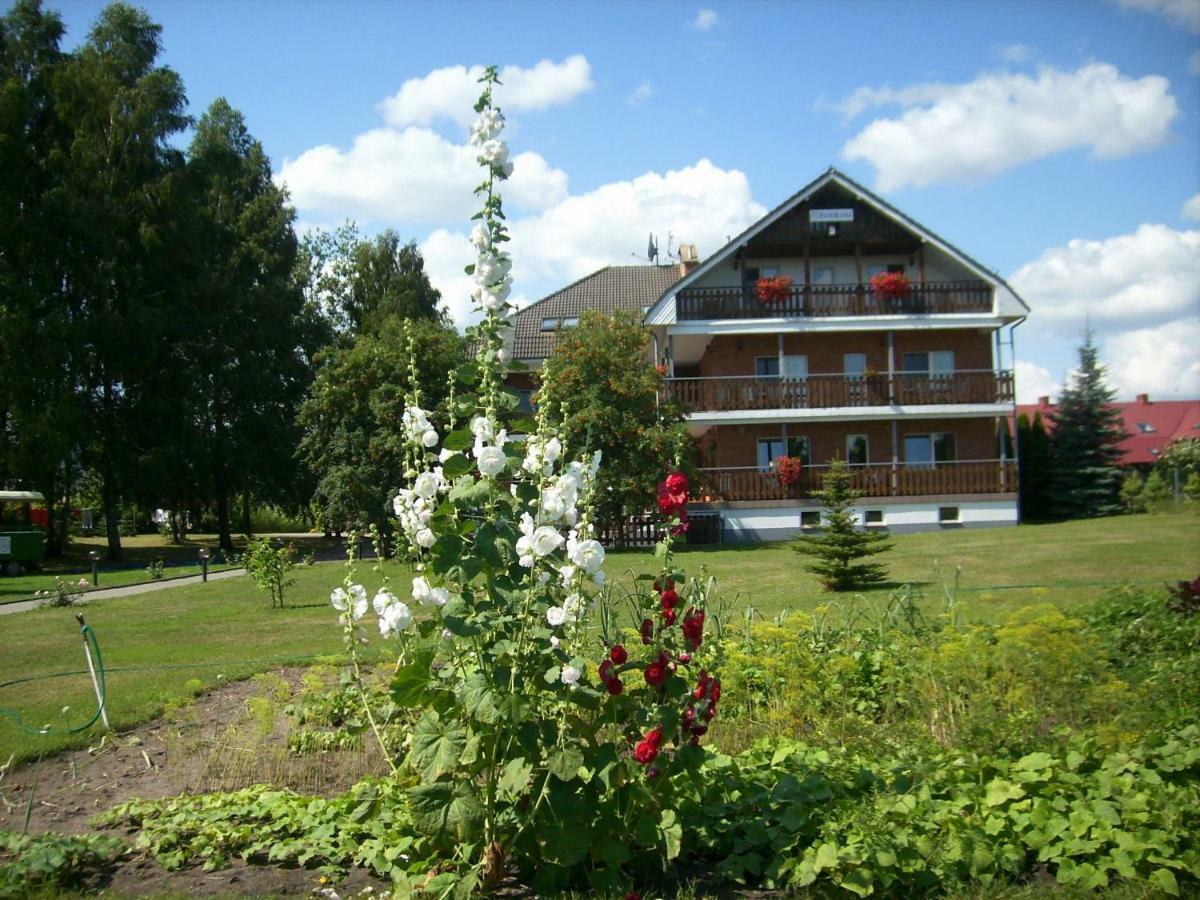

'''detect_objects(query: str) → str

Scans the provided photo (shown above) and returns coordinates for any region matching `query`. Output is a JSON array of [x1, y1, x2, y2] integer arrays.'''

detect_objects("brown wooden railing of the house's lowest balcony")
[[692, 460, 1016, 503]]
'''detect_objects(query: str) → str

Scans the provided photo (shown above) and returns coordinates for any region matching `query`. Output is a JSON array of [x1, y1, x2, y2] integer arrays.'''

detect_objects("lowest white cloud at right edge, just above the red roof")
[[1102, 318, 1200, 400]]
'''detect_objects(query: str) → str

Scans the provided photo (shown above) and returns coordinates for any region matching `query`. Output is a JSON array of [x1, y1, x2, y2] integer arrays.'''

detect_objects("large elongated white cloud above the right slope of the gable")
[[836, 62, 1178, 191]]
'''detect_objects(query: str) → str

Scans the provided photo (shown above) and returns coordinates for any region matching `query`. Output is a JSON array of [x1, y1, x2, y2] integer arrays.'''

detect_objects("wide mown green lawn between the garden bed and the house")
[[0, 515, 1200, 764]]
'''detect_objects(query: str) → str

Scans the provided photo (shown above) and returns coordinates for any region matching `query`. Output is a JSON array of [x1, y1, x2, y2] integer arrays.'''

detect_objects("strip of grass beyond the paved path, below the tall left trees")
[[0, 534, 337, 604]]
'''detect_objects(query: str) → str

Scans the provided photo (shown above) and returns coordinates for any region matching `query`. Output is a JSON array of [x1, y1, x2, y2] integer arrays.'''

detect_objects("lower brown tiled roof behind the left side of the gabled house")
[[512, 265, 679, 360]]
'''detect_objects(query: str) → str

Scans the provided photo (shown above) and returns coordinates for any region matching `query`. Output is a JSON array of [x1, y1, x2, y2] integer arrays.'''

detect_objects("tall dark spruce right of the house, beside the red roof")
[[1050, 332, 1124, 518]]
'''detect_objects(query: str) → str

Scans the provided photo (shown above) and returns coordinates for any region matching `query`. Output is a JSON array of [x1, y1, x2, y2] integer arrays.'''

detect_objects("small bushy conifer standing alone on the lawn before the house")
[[794, 460, 894, 590]]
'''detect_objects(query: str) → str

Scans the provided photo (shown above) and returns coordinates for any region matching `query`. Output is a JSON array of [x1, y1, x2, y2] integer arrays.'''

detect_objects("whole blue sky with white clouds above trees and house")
[[48, 0, 1200, 400]]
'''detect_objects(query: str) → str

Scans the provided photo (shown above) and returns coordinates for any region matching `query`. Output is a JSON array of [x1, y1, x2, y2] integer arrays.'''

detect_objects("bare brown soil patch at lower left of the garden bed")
[[0, 668, 391, 898]]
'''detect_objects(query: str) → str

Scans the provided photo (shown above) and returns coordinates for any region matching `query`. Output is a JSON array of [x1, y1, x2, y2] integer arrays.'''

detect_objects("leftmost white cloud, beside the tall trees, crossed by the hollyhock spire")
[[276, 127, 566, 222]]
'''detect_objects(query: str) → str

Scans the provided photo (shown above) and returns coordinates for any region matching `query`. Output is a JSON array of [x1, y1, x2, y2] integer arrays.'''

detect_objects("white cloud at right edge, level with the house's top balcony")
[[1009, 224, 1200, 335]]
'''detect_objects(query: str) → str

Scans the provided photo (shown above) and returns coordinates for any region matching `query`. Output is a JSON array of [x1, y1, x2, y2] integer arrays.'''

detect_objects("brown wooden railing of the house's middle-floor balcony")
[[662, 370, 1015, 413]]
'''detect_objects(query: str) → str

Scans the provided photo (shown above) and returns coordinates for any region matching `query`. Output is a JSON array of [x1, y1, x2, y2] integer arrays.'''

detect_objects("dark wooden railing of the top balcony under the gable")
[[676, 281, 992, 322]]
